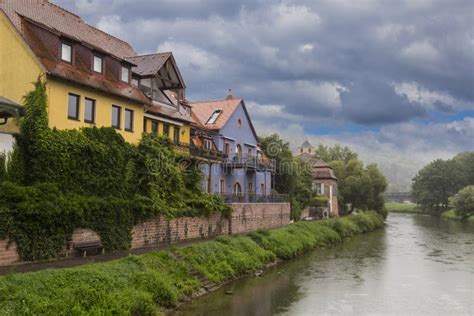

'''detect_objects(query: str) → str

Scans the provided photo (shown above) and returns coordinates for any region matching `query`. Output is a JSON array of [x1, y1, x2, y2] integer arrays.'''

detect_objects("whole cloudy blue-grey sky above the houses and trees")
[[53, 0, 474, 190]]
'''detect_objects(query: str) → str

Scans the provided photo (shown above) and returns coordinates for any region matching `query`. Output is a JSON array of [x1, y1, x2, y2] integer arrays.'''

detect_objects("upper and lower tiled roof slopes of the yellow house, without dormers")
[[0, 0, 150, 104]]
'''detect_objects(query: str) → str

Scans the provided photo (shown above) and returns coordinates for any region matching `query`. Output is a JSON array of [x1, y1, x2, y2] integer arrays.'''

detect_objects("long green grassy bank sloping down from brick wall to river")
[[0, 212, 383, 315]]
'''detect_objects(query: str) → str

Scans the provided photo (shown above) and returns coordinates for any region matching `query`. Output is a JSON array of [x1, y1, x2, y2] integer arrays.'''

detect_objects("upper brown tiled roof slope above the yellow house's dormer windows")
[[0, 0, 136, 59]]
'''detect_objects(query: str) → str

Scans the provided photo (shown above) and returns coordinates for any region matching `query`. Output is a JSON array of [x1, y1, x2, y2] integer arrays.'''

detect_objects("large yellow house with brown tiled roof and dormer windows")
[[0, 0, 192, 150]]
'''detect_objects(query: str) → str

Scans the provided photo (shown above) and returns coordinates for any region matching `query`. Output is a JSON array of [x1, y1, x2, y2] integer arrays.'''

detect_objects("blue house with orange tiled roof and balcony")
[[189, 95, 275, 202]]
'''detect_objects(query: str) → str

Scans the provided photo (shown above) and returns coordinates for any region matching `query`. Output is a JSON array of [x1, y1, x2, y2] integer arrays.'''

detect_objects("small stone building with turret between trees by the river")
[[297, 140, 339, 217]]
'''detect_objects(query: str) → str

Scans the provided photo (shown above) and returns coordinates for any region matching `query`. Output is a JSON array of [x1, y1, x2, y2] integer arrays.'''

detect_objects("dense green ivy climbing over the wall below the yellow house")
[[0, 79, 231, 260]]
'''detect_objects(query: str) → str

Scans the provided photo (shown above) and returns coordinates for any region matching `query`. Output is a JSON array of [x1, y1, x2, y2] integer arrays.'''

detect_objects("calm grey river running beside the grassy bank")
[[173, 214, 474, 316]]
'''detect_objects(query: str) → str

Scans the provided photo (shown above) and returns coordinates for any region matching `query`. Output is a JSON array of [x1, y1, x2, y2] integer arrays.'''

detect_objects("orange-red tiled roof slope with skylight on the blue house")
[[189, 99, 242, 130]]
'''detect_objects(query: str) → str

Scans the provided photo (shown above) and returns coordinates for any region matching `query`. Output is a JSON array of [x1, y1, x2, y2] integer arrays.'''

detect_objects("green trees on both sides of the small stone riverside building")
[[260, 134, 387, 219]]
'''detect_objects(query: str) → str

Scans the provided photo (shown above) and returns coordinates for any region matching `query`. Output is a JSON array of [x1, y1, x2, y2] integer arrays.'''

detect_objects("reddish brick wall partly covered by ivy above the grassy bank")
[[0, 203, 290, 265]]
